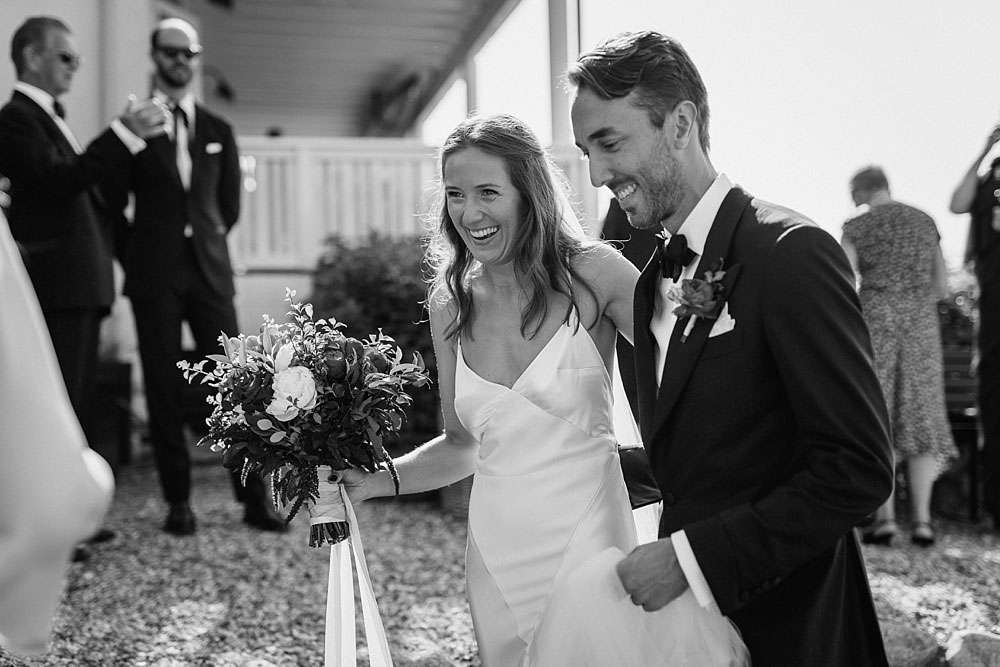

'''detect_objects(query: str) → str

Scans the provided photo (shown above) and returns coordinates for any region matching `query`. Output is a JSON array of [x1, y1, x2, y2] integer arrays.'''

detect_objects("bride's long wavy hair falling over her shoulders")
[[426, 114, 600, 339]]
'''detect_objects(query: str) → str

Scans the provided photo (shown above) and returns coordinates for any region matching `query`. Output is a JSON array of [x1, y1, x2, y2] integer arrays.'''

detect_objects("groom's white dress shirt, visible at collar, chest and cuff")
[[649, 173, 733, 607]]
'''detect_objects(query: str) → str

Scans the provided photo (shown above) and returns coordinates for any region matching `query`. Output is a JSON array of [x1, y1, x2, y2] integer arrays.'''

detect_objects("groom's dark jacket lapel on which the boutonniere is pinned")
[[648, 188, 750, 439]]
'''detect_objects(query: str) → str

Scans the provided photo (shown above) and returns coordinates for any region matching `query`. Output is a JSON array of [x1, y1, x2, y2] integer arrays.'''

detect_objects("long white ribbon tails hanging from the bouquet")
[[324, 485, 392, 667]]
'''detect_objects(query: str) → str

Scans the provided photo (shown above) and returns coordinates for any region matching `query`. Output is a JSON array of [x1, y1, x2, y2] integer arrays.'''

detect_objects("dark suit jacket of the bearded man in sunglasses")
[[105, 105, 240, 299]]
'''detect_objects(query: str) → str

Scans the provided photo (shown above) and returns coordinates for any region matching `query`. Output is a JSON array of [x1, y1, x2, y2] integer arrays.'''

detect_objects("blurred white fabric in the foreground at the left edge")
[[0, 213, 114, 653]]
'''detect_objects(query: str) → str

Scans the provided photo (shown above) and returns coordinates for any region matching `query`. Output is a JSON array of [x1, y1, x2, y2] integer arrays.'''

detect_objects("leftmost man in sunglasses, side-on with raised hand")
[[0, 16, 169, 559]]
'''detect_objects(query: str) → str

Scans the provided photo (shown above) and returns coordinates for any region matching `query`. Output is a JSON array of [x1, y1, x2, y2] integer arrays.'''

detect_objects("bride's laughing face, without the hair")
[[444, 148, 524, 264]]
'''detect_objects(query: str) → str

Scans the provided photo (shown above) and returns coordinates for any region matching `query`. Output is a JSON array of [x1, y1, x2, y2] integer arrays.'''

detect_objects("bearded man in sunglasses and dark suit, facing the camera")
[[105, 19, 285, 535]]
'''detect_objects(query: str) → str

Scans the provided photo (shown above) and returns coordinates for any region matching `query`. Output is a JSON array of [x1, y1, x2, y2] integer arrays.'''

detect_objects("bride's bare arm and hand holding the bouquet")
[[344, 299, 478, 502]]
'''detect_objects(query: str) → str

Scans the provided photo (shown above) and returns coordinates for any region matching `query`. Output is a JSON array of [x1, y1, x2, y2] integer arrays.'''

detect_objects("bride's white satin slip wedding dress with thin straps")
[[455, 324, 746, 667]]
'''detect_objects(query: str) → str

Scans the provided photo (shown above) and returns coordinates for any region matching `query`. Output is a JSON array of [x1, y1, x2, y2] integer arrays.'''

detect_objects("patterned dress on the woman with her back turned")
[[844, 202, 958, 471]]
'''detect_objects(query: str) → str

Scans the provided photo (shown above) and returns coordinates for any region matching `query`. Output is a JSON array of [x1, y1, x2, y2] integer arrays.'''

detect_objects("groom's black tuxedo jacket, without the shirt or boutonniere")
[[635, 188, 893, 667]]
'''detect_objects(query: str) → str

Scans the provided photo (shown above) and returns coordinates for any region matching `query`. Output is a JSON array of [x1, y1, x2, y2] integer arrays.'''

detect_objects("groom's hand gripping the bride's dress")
[[616, 537, 688, 611]]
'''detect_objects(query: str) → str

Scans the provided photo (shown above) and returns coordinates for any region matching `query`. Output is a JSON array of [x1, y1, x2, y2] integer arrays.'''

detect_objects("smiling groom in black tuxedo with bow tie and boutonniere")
[[568, 32, 893, 667]]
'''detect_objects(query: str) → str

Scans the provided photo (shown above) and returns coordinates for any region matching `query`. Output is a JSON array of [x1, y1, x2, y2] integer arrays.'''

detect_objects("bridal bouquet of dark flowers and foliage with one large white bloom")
[[178, 290, 430, 547]]
